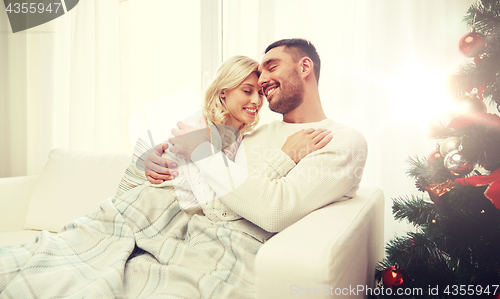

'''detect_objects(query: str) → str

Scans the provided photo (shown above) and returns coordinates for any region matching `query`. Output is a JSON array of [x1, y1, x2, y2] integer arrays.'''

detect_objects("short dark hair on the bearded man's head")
[[264, 38, 321, 83]]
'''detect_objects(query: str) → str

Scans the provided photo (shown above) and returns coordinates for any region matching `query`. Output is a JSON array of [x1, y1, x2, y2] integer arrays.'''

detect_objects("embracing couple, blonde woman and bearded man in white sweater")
[[141, 39, 367, 232]]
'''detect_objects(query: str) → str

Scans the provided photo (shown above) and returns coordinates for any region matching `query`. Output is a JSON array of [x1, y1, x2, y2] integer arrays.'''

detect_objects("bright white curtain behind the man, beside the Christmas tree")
[[223, 0, 475, 240]]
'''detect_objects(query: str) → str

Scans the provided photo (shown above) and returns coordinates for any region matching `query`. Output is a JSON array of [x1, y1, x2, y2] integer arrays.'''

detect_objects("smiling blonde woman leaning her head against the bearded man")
[[120, 56, 327, 222]]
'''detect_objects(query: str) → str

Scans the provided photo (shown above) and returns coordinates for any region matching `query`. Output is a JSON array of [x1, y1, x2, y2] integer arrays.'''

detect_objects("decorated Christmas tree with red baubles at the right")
[[374, 0, 500, 298]]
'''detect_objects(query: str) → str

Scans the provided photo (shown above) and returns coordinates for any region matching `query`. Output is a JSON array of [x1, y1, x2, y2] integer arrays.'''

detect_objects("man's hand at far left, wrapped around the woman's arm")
[[144, 144, 179, 184]]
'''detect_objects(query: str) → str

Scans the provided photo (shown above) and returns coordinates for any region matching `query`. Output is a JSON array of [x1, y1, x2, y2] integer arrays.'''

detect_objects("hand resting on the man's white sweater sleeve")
[[281, 128, 333, 163]]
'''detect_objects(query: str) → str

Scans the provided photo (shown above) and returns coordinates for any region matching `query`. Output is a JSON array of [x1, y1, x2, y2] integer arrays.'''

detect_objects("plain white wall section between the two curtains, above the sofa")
[[130, 0, 202, 110]]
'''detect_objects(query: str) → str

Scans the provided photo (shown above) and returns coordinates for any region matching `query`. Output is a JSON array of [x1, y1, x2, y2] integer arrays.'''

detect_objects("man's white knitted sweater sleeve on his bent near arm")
[[196, 131, 367, 232]]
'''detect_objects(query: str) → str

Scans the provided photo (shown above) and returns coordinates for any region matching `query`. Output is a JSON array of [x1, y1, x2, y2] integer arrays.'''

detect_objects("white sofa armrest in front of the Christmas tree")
[[255, 187, 384, 298]]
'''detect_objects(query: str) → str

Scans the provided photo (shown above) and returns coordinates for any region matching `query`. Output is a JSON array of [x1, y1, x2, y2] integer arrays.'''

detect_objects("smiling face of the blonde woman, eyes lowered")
[[223, 73, 263, 128]]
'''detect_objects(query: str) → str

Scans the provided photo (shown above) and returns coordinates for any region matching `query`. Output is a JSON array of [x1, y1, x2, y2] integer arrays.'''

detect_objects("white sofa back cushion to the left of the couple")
[[24, 149, 132, 232]]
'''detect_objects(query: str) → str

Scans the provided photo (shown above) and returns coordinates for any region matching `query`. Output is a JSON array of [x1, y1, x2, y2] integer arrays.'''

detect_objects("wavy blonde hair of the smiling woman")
[[203, 56, 259, 135]]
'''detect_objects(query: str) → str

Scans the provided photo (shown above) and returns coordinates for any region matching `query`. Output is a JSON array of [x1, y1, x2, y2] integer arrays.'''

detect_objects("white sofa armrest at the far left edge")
[[0, 175, 38, 232]]
